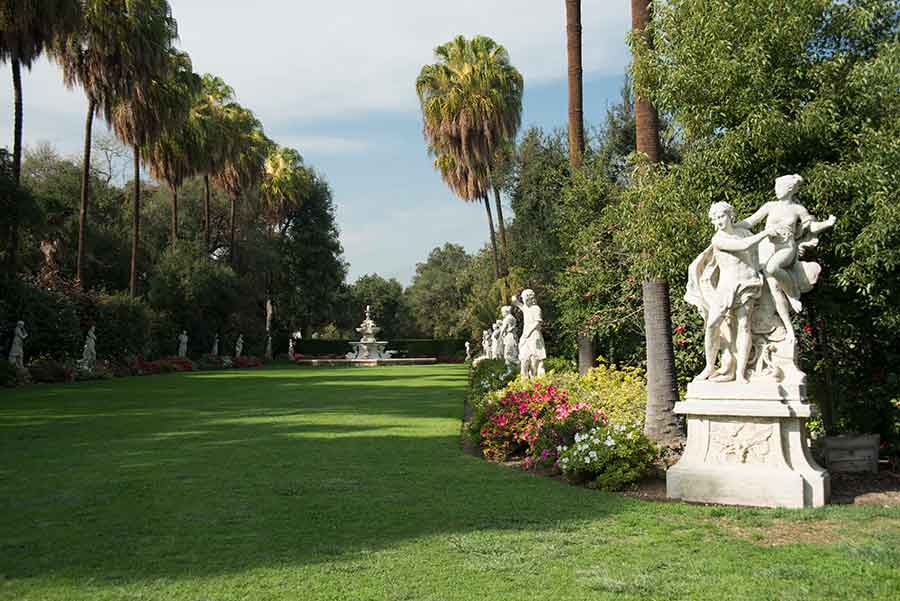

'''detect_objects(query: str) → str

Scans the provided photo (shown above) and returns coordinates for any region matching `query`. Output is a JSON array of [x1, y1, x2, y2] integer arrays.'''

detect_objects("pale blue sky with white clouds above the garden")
[[0, 0, 630, 285]]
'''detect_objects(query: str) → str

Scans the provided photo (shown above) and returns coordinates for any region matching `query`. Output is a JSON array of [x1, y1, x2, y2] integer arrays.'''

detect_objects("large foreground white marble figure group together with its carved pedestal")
[[666, 175, 835, 507]]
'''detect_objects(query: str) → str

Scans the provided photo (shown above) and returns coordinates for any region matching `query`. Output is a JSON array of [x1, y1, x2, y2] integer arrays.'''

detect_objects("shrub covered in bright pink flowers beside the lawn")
[[479, 380, 603, 467]]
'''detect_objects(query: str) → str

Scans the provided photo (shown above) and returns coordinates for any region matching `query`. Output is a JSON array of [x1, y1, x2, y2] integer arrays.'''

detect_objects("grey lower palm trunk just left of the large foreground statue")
[[643, 279, 683, 446]]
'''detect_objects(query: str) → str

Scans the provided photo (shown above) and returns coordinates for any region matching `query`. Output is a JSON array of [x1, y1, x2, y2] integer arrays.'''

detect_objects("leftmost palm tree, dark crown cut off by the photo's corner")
[[0, 0, 81, 271]]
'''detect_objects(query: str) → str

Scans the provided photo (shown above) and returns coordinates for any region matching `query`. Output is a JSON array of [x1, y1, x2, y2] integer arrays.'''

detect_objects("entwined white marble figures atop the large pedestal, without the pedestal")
[[685, 175, 835, 383]]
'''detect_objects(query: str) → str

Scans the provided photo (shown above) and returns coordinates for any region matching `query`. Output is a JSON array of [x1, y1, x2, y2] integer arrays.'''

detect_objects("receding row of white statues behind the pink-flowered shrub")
[[466, 289, 547, 378]]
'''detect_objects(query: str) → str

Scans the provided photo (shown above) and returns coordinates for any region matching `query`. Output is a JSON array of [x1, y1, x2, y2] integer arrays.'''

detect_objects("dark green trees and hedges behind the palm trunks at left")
[[0, 140, 346, 361]]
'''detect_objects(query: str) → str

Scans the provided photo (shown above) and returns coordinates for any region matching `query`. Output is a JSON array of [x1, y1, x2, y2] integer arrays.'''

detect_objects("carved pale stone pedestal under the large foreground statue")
[[666, 382, 830, 507]]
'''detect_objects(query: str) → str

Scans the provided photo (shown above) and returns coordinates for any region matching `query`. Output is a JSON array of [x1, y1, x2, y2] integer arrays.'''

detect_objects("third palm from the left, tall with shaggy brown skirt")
[[109, 0, 178, 297]]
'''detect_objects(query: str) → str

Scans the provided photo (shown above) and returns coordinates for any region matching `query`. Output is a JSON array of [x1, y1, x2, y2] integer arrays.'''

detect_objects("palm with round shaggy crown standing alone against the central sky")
[[416, 36, 524, 278]]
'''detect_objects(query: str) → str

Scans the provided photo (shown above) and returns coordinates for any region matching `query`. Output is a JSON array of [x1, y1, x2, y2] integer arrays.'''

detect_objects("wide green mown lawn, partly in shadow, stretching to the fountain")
[[0, 366, 900, 601]]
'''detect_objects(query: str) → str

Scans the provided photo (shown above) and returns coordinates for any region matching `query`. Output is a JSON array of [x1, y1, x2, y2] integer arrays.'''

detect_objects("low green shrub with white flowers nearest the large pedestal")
[[556, 423, 657, 490]]
